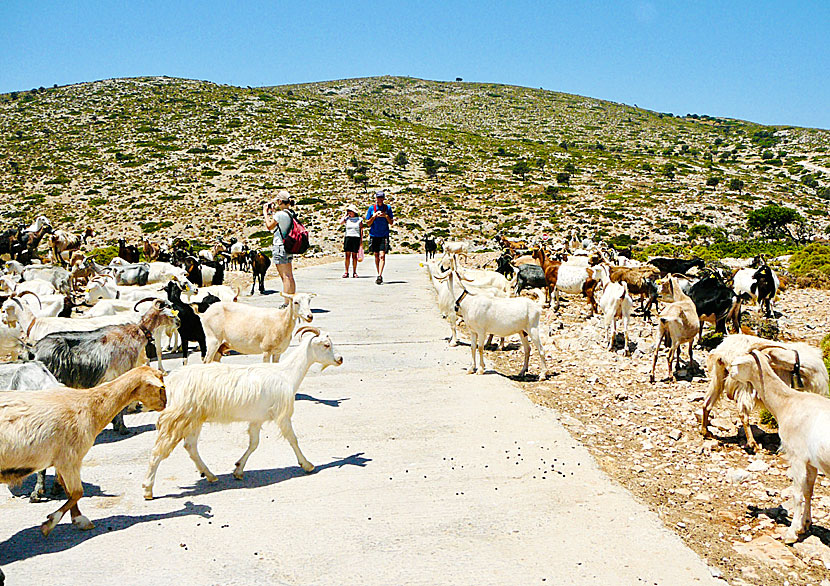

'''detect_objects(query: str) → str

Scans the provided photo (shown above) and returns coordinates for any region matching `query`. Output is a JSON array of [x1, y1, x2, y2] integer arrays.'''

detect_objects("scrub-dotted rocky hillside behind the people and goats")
[[0, 77, 830, 251]]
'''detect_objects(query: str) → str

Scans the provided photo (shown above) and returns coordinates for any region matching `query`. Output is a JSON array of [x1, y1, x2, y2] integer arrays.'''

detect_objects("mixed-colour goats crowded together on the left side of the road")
[[0, 213, 343, 582]]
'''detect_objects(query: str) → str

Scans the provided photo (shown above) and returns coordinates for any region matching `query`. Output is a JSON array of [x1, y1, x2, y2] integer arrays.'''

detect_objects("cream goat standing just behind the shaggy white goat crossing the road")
[[201, 293, 314, 362]]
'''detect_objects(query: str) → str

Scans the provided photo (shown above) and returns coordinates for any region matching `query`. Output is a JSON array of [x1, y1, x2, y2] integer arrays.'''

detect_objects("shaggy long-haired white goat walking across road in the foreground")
[[143, 327, 343, 500]]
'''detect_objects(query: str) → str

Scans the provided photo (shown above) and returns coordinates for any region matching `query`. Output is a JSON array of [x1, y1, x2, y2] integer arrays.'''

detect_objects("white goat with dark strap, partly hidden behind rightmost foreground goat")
[[700, 334, 828, 451]]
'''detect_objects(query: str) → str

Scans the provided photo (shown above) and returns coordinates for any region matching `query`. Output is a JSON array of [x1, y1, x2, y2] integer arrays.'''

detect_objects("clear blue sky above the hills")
[[0, 0, 830, 128]]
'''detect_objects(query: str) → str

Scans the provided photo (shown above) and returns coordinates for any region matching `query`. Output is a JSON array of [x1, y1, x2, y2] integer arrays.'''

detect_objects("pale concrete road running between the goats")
[[0, 256, 723, 586]]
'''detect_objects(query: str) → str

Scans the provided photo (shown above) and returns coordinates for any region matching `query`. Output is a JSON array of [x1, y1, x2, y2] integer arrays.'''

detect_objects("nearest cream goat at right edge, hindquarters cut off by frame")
[[727, 350, 830, 543]]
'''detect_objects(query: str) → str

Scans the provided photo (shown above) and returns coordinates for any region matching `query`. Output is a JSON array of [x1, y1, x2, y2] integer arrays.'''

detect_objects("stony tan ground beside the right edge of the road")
[[478, 280, 830, 585]]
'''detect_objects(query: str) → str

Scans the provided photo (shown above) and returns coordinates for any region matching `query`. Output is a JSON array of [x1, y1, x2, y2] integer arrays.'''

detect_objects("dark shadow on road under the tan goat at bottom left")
[[0, 501, 213, 565]]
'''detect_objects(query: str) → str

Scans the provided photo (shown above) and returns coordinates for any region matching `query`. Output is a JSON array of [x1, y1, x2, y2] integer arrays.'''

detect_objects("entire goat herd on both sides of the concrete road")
[[0, 217, 830, 576]]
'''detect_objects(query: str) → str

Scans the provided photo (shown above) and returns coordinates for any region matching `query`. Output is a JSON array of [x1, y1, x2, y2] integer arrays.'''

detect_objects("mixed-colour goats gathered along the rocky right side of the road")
[[424, 233, 830, 543]]
